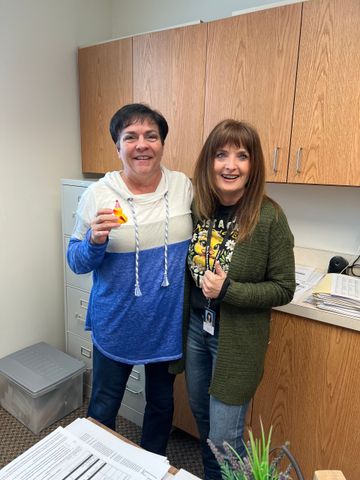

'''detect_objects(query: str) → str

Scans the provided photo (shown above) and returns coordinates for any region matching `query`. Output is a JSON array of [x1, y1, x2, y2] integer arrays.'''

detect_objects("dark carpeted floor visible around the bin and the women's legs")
[[0, 404, 202, 478]]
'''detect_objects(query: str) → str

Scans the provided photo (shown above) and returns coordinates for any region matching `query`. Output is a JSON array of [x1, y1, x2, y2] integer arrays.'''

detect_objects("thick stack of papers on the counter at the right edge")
[[313, 273, 360, 318]]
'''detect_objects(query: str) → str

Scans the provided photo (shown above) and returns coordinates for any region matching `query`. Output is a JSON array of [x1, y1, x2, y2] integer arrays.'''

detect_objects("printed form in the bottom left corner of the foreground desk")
[[0, 427, 143, 480]]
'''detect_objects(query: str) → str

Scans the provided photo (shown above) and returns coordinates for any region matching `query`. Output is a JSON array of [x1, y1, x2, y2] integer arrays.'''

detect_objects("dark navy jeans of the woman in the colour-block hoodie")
[[88, 345, 175, 455]]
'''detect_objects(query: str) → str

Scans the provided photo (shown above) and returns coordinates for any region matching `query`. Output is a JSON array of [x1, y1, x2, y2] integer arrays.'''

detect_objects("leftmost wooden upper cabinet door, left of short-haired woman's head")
[[78, 38, 132, 173]]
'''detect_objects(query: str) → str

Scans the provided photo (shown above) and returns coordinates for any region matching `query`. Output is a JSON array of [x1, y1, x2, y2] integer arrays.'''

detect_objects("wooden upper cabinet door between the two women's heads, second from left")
[[133, 24, 206, 176]]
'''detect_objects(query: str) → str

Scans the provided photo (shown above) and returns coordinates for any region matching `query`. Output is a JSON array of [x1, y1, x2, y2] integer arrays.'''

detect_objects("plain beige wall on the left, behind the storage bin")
[[0, 0, 111, 357]]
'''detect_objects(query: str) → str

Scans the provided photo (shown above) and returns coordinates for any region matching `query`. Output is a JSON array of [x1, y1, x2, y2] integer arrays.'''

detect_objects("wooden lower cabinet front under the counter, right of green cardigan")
[[252, 312, 360, 479]]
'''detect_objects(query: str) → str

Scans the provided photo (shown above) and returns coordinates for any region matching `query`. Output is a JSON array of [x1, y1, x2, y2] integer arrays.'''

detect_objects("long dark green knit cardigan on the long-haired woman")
[[170, 198, 295, 405]]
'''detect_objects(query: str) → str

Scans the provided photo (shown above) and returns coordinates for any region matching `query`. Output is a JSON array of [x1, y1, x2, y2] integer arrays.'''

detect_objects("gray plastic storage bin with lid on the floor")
[[0, 342, 86, 433]]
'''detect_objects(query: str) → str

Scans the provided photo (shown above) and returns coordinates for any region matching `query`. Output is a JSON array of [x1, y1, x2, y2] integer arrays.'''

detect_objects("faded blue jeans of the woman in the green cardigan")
[[186, 311, 248, 480]]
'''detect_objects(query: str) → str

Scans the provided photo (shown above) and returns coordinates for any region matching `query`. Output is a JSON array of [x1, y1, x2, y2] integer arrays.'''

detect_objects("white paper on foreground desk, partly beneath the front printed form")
[[66, 418, 170, 480]]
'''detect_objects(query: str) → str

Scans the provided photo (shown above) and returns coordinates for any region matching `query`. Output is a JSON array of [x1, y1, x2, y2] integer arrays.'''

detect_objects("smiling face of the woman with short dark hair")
[[118, 119, 164, 188]]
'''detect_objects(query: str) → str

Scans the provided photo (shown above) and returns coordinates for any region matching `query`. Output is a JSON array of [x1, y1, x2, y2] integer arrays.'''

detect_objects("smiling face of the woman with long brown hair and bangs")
[[213, 145, 250, 205]]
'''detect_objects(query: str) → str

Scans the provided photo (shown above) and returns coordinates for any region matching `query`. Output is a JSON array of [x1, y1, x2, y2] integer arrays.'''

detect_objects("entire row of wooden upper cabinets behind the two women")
[[79, 0, 360, 186]]
